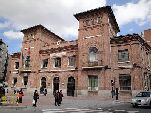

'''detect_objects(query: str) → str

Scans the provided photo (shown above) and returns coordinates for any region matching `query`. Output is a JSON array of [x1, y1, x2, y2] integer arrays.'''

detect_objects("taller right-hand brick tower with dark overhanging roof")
[[74, 6, 119, 94]]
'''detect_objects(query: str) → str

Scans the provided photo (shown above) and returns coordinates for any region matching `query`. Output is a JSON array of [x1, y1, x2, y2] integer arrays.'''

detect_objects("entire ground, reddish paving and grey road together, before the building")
[[0, 93, 151, 113]]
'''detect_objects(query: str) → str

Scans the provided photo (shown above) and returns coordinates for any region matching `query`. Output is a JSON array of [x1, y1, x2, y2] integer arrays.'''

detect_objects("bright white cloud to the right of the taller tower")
[[113, 0, 151, 26]]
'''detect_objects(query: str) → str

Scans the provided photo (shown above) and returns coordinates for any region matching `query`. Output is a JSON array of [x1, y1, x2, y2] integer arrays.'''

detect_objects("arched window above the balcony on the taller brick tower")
[[89, 47, 98, 62]]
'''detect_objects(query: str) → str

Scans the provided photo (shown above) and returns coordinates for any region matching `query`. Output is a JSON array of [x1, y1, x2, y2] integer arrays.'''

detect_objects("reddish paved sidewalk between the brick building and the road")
[[0, 92, 130, 113]]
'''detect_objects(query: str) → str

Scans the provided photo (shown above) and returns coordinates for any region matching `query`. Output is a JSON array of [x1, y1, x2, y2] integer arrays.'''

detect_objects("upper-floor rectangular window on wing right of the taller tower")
[[118, 49, 129, 62]]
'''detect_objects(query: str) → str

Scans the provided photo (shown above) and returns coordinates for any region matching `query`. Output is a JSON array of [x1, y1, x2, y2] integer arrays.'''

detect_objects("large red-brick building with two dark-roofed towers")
[[8, 6, 151, 96]]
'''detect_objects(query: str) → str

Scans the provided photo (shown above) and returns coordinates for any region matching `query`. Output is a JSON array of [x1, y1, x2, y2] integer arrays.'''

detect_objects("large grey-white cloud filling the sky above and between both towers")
[[0, 0, 106, 40]]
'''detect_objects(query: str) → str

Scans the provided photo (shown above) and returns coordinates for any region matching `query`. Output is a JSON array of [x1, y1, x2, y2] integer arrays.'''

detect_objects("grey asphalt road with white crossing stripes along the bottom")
[[0, 103, 151, 113]]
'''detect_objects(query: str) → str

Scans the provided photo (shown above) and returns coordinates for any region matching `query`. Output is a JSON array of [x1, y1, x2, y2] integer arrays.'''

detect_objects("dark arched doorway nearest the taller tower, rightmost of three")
[[67, 77, 75, 96]]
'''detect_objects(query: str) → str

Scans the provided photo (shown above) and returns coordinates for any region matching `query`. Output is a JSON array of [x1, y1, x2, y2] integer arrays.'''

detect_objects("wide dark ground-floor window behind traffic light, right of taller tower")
[[119, 74, 131, 90]]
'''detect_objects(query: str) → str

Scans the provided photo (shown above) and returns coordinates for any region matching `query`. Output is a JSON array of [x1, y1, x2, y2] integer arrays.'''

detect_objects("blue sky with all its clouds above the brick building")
[[0, 0, 151, 54]]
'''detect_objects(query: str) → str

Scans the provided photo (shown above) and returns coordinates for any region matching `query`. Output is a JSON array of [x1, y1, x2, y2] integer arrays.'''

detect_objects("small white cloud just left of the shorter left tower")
[[3, 30, 23, 40]]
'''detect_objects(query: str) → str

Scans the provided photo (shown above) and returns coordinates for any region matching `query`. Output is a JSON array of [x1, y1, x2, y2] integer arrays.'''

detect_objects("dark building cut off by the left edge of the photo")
[[0, 39, 8, 84]]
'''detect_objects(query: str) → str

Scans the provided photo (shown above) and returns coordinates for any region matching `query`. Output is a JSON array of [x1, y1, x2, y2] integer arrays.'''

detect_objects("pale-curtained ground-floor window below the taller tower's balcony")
[[88, 76, 98, 91]]
